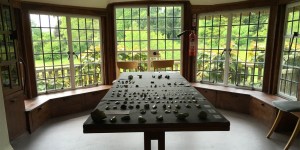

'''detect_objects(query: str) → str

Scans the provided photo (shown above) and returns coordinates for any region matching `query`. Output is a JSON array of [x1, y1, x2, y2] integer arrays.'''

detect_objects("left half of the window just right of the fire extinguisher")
[[196, 14, 228, 83]]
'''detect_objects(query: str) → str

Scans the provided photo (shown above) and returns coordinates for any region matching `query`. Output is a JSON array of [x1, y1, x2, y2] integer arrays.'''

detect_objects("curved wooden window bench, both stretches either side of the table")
[[25, 83, 297, 132]]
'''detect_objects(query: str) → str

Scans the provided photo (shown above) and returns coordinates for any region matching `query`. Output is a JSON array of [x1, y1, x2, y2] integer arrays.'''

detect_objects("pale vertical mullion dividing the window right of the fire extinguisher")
[[223, 14, 233, 86]]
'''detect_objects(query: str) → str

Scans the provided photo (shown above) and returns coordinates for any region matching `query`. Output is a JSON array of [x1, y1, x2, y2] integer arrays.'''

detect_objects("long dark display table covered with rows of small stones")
[[83, 72, 230, 150]]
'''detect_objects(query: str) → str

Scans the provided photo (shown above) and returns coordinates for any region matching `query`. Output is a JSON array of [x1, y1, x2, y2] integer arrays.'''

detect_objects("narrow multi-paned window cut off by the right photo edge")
[[279, 3, 300, 100]]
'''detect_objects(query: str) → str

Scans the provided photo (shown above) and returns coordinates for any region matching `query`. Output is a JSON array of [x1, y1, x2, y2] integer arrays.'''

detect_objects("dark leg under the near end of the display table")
[[144, 132, 165, 150]]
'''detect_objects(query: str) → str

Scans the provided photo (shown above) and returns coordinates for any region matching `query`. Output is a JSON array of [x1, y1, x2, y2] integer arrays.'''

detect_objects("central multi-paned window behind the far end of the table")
[[115, 6, 182, 71]]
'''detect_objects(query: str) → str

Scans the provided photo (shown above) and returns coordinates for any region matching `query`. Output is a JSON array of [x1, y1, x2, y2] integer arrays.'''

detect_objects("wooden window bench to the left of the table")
[[25, 85, 111, 133]]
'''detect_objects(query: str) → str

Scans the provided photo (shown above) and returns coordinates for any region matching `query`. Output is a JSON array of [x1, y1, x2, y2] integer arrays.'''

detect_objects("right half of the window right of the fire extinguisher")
[[229, 10, 269, 88]]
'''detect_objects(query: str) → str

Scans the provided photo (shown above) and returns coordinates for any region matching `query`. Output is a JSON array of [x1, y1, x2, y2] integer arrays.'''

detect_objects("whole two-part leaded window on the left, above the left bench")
[[30, 13, 102, 93]]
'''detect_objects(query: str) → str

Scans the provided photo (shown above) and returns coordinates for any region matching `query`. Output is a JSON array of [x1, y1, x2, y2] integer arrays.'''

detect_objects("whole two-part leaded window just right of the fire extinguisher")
[[197, 10, 269, 88]]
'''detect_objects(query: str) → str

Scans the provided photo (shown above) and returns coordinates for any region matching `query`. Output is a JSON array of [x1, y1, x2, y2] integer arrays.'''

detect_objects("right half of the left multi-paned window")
[[71, 17, 102, 87]]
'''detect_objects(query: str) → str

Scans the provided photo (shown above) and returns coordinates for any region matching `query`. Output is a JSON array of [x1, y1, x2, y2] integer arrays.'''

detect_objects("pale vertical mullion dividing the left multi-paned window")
[[66, 16, 75, 89]]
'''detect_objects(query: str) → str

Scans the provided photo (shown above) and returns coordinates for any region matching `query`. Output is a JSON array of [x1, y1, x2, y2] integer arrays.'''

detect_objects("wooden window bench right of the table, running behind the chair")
[[192, 83, 297, 132]]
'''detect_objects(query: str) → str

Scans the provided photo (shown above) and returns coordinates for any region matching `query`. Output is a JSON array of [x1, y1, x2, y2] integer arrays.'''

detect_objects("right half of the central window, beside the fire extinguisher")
[[150, 6, 182, 71]]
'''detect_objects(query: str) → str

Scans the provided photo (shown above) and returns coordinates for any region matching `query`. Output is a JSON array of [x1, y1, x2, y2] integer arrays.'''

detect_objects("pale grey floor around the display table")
[[12, 110, 300, 150]]
